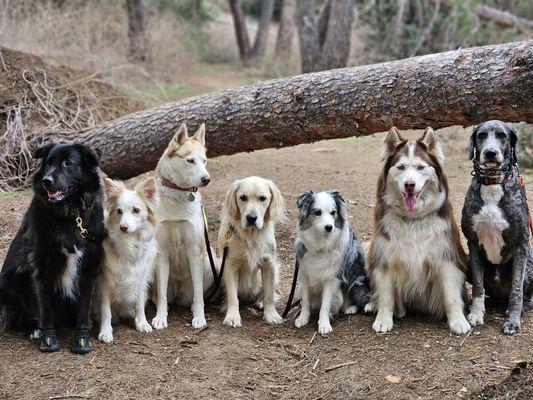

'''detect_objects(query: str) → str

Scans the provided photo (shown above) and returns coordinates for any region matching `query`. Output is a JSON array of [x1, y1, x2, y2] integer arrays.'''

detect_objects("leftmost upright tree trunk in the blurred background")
[[126, 0, 150, 63]]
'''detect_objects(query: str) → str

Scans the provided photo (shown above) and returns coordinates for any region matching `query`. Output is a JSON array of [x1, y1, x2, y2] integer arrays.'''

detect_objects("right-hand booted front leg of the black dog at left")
[[70, 276, 95, 354]]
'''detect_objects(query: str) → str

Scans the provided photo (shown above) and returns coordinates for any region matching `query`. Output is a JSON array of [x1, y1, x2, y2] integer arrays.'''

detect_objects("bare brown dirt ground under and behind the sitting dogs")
[[0, 129, 533, 399]]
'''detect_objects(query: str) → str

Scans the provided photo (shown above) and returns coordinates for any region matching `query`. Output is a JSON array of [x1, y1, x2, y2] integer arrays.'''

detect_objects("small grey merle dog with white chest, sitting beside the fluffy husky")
[[294, 190, 370, 335]]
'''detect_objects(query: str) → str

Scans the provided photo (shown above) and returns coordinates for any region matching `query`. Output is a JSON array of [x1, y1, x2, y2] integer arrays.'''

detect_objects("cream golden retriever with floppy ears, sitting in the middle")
[[218, 176, 285, 327]]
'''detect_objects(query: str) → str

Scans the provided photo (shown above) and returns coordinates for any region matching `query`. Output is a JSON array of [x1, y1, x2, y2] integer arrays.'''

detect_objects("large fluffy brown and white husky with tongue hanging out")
[[367, 127, 470, 334]]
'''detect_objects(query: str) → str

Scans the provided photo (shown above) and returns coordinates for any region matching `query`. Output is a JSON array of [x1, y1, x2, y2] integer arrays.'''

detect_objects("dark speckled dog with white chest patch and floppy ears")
[[461, 121, 533, 335]]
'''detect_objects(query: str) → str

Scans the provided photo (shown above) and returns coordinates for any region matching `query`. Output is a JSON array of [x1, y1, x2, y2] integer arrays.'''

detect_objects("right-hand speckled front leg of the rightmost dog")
[[503, 243, 529, 335]]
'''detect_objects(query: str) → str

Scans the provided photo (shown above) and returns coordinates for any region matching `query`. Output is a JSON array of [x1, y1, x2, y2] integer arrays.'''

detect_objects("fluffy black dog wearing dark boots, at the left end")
[[0, 144, 105, 354]]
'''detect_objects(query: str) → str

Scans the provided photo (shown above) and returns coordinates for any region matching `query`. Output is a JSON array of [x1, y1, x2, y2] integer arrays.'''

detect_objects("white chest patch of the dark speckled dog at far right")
[[472, 185, 509, 264]]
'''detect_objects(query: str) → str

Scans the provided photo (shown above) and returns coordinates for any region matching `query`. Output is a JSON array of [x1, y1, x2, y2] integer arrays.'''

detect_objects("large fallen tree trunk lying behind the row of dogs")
[[71, 41, 533, 178]]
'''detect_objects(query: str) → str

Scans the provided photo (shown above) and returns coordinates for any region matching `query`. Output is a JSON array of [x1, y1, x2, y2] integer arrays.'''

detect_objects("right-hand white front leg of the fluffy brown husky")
[[439, 262, 471, 335]]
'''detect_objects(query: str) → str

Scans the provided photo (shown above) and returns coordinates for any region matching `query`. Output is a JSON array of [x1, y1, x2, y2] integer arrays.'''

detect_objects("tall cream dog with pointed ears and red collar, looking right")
[[152, 124, 214, 329]]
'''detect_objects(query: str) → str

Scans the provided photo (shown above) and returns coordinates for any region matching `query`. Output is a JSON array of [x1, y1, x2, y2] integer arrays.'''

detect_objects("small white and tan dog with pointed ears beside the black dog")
[[96, 178, 157, 343]]
